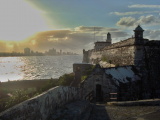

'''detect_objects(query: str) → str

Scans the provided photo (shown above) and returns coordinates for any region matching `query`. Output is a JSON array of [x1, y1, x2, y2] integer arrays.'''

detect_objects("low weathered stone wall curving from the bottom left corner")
[[0, 86, 84, 120]]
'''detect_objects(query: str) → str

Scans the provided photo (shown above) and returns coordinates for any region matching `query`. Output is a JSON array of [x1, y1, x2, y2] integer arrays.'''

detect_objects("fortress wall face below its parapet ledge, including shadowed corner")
[[85, 42, 144, 66]]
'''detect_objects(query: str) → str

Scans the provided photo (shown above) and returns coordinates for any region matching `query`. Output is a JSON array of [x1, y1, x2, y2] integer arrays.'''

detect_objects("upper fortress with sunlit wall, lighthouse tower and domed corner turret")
[[83, 26, 152, 66]]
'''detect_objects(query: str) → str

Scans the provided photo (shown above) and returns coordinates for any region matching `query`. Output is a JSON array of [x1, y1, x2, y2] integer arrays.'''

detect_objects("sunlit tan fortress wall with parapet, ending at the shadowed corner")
[[83, 38, 138, 65]]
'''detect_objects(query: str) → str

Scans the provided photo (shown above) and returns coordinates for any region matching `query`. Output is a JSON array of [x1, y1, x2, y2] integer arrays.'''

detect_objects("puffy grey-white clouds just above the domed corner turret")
[[116, 15, 160, 27]]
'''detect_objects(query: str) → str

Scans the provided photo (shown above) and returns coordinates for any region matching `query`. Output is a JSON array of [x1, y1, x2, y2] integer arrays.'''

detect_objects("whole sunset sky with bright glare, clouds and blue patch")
[[0, 0, 160, 54]]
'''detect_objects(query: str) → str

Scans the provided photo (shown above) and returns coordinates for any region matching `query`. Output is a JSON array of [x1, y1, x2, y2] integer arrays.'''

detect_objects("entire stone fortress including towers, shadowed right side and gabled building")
[[73, 25, 160, 101]]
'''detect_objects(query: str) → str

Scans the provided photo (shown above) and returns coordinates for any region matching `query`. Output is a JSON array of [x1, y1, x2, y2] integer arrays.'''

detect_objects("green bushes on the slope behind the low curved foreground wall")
[[0, 74, 74, 112]]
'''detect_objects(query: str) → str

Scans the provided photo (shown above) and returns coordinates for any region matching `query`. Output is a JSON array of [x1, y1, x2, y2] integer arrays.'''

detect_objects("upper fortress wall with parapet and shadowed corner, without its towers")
[[83, 38, 152, 66]]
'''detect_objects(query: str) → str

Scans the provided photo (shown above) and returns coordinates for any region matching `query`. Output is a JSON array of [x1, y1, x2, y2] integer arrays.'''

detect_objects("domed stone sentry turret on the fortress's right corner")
[[133, 25, 144, 40]]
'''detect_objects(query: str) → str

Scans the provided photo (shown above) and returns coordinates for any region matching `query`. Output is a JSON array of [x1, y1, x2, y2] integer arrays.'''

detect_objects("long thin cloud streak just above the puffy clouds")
[[109, 11, 160, 15]]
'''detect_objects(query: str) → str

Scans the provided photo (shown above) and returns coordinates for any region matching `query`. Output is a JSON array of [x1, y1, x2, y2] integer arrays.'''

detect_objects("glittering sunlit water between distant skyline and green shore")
[[0, 55, 82, 82]]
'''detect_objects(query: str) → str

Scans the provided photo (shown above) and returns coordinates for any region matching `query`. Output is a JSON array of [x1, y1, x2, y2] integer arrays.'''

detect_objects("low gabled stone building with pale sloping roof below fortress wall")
[[81, 65, 142, 101]]
